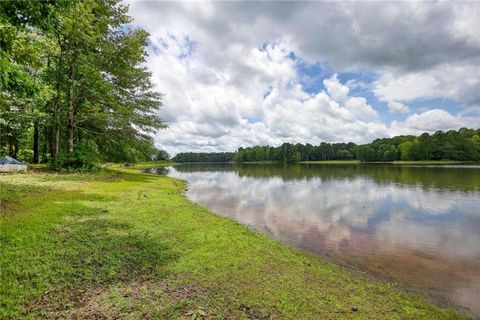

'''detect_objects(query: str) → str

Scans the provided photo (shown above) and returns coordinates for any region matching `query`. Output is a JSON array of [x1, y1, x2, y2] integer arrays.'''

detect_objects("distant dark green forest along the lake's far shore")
[[172, 128, 480, 163]]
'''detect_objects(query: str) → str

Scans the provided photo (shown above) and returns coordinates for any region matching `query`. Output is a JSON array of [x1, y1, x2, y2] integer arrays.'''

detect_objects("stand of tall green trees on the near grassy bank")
[[0, 0, 164, 166]]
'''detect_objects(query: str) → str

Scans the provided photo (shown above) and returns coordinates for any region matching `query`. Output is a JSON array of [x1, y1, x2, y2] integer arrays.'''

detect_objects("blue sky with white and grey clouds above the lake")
[[127, 0, 480, 154]]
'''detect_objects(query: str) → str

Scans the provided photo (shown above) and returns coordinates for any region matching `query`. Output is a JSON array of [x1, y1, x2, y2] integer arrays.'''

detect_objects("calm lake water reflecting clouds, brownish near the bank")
[[160, 164, 480, 316]]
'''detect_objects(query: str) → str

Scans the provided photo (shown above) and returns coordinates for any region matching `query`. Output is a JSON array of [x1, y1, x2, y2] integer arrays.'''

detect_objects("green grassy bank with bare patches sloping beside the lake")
[[0, 167, 463, 319]]
